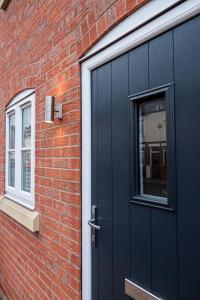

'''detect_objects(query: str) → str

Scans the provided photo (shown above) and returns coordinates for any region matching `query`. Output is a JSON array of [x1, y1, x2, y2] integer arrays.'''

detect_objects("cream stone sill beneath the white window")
[[0, 196, 39, 232]]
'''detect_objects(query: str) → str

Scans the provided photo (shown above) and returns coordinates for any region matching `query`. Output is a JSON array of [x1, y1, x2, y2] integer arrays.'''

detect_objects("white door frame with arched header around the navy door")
[[80, 0, 200, 300]]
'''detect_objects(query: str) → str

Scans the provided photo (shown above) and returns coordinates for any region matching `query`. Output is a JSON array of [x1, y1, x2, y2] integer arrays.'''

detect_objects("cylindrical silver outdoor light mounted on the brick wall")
[[45, 96, 62, 123]]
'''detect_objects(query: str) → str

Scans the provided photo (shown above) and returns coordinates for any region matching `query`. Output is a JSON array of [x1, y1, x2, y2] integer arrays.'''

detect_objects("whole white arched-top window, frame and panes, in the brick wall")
[[6, 90, 35, 209]]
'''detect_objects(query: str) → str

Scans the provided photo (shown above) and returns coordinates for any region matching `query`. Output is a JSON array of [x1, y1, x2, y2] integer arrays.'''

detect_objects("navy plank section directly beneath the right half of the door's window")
[[151, 209, 178, 300]]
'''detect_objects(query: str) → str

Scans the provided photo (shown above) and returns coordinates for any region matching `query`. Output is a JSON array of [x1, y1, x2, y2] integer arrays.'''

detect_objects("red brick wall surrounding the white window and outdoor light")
[[0, 0, 147, 300]]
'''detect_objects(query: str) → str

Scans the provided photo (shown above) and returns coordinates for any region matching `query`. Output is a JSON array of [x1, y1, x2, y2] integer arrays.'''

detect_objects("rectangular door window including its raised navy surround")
[[130, 86, 175, 209]]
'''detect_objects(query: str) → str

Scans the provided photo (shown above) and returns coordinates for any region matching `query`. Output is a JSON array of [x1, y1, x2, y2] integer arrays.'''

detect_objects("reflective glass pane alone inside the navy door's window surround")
[[139, 98, 167, 198]]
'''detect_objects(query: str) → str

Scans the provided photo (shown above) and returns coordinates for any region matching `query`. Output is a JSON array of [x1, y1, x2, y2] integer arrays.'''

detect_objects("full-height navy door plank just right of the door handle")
[[98, 63, 113, 300]]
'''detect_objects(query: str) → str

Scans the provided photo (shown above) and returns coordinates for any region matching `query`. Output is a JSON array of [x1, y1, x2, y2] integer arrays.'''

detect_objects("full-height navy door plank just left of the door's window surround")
[[112, 54, 130, 300]]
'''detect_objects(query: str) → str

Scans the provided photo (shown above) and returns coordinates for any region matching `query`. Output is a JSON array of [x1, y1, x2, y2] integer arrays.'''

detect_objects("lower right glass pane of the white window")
[[22, 150, 31, 193]]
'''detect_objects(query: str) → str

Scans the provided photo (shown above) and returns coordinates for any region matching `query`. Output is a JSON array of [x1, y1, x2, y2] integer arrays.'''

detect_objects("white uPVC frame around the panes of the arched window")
[[5, 90, 35, 210]]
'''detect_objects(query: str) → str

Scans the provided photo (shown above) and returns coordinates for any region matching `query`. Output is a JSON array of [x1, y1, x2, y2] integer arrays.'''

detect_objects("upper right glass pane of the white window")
[[22, 106, 31, 148]]
